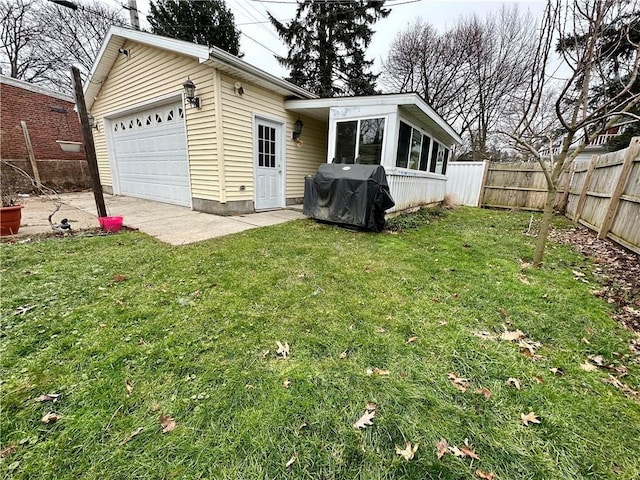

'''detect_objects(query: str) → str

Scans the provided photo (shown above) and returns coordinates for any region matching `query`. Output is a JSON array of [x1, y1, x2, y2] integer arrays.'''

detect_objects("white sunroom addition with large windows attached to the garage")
[[285, 94, 462, 210]]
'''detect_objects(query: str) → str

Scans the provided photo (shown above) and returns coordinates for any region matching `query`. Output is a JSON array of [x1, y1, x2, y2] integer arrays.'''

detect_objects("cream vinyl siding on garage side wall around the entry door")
[[221, 74, 327, 201]]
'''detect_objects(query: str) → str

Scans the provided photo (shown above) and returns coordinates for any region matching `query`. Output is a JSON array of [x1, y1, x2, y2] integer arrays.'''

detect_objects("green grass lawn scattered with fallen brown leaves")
[[0, 209, 640, 480]]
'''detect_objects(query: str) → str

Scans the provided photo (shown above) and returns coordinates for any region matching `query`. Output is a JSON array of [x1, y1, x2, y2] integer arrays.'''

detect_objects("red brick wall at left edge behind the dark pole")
[[0, 79, 91, 189]]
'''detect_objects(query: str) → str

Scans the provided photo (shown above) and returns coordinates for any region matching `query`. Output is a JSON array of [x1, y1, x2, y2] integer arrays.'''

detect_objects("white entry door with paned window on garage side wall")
[[253, 118, 284, 210]]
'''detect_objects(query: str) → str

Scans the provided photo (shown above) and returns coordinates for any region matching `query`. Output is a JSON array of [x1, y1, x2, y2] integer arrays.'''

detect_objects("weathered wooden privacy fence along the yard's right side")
[[480, 137, 640, 253]]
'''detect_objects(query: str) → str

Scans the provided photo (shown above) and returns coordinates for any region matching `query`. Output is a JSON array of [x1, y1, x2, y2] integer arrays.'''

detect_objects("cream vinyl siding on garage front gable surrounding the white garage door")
[[91, 41, 220, 200]]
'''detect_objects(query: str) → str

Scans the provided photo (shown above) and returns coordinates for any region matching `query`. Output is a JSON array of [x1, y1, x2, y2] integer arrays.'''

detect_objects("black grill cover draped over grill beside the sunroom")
[[303, 163, 395, 232]]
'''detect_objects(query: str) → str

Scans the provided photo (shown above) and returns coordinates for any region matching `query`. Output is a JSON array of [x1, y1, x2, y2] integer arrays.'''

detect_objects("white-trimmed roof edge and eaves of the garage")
[[84, 26, 318, 109]]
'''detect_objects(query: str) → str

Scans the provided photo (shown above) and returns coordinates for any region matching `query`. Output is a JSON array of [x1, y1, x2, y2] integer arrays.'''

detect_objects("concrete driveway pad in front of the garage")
[[18, 192, 306, 245]]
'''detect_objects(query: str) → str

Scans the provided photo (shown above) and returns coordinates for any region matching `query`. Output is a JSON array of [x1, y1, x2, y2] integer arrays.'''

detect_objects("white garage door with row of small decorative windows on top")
[[111, 102, 191, 206]]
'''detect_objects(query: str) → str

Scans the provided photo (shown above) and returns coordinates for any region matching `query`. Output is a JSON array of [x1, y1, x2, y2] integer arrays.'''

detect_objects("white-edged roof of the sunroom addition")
[[284, 93, 462, 145]]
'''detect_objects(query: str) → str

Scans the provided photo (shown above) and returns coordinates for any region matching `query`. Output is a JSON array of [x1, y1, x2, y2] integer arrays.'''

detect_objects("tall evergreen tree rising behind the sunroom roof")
[[269, 0, 390, 97]]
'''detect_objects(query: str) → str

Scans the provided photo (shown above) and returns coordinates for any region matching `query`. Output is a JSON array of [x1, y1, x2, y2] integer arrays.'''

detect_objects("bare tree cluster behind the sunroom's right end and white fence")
[[382, 5, 536, 160]]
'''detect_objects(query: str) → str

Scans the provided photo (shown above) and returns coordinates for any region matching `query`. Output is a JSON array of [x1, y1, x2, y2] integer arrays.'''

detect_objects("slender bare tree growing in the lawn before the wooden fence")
[[504, 0, 640, 266]]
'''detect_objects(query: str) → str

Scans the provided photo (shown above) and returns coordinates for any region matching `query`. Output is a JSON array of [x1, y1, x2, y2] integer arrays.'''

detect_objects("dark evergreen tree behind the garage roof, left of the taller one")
[[147, 0, 240, 56]]
